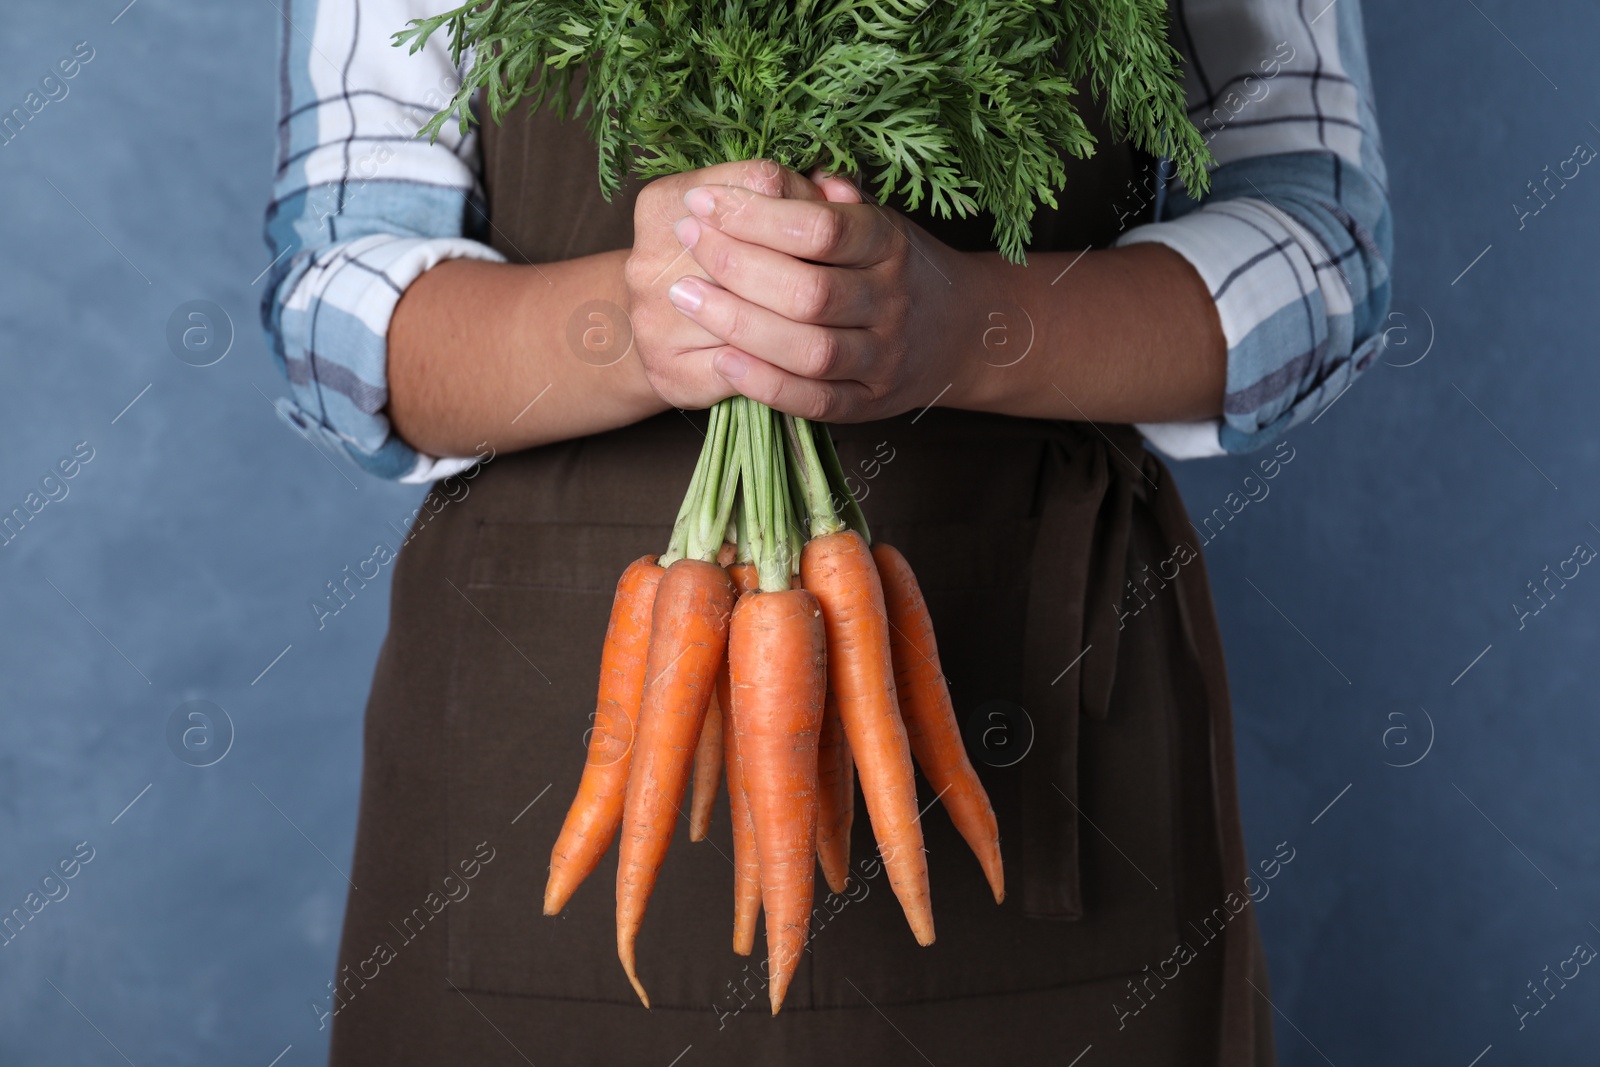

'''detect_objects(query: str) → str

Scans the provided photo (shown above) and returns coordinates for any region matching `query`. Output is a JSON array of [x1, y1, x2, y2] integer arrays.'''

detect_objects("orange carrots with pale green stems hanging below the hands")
[[544, 397, 1005, 1014]]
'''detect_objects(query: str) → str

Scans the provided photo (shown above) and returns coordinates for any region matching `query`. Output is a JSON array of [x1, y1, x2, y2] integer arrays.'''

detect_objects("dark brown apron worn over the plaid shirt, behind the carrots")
[[318, 85, 1274, 1067]]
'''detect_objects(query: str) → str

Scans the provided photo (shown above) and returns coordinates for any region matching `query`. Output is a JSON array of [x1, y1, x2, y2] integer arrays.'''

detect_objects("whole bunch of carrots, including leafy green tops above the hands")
[[395, 0, 1211, 1014]]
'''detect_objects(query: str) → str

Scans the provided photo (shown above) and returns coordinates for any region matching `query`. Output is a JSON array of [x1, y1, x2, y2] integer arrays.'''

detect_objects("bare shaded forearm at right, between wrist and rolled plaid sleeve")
[[939, 245, 1227, 422]]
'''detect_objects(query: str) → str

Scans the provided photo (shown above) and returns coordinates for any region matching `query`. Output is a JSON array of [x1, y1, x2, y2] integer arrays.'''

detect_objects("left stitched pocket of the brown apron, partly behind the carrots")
[[446, 522, 760, 1011]]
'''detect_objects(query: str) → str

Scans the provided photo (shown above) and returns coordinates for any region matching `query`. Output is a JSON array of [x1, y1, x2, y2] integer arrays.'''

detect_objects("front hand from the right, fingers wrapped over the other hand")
[[669, 171, 982, 422]]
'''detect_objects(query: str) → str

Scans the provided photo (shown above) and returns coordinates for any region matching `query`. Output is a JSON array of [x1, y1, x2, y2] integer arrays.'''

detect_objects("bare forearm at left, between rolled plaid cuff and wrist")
[[387, 251, 667, 456]]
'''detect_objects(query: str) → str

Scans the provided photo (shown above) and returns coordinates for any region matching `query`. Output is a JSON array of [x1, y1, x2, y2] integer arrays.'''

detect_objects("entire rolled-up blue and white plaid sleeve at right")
[[1118, 0, 1392, 459]]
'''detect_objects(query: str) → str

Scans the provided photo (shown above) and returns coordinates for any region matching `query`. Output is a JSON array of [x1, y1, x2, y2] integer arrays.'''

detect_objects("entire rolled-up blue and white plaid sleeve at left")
[[261, 0, 501, 482]]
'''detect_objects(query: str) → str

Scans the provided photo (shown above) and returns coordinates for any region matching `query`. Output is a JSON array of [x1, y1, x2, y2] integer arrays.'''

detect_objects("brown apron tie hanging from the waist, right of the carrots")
[[1019, 424, 1256, 1064]]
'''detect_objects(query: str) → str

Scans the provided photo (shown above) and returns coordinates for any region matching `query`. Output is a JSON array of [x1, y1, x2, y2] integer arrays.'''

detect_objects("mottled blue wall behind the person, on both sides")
[[0, 0, 1600, 1065]]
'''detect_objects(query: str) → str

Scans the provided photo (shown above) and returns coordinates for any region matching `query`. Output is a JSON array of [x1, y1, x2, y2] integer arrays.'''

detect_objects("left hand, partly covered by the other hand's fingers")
[[624, 160, 822, 408]]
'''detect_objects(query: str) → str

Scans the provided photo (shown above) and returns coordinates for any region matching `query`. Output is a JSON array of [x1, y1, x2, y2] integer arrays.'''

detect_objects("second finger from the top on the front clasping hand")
[[675, 216, 875, 326]]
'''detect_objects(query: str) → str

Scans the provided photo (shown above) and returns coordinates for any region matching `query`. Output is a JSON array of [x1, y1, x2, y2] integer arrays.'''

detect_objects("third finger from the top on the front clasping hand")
[[667, 278, 872, 381]]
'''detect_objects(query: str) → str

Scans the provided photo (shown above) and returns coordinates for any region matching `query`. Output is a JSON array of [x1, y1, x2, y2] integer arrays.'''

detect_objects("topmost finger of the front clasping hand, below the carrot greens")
[[683, 181, 901, 267]]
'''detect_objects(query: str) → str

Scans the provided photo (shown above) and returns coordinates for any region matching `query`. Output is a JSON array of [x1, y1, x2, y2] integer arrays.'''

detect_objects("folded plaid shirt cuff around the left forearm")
[[278, 234, 504, 482]]
